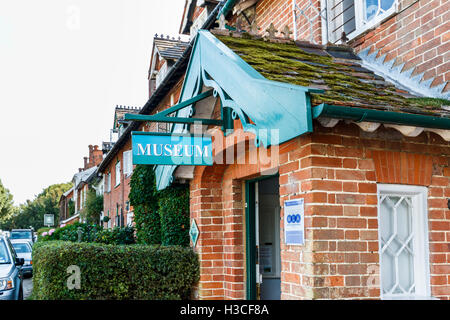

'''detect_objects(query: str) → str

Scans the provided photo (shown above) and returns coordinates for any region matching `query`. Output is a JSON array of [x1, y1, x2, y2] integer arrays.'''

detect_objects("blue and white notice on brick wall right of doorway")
[[284, 198, 305, 245]]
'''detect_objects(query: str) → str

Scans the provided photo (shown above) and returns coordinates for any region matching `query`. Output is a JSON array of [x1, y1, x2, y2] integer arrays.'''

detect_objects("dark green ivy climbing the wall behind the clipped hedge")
[[129, 165, 189, 246]]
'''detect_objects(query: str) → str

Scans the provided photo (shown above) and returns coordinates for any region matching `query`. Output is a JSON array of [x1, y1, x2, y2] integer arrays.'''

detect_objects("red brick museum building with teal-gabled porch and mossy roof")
[[100, 0, 450, 299]]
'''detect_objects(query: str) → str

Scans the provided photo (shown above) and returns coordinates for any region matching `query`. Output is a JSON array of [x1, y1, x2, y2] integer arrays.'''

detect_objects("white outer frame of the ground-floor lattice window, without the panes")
[[377, 184, 431, 299]]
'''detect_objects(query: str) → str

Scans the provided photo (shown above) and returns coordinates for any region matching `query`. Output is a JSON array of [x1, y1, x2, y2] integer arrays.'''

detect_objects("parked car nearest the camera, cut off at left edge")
[[0, 236, 24, 300]]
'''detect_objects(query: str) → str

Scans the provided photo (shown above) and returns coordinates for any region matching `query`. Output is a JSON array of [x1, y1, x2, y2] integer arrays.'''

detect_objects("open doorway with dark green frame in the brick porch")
[[246, 176, 281, 300]]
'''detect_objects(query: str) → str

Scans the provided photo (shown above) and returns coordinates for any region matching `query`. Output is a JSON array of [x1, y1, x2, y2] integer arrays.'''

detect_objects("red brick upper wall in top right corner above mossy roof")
[[352, 0, 450, 90]]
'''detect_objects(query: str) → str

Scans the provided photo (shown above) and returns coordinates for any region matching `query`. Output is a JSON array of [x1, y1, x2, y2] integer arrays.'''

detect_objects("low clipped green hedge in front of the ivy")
[[33, 241, 199, 300]]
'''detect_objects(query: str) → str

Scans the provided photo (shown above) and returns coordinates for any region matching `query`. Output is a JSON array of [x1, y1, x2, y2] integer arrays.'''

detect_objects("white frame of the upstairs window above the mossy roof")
[[328, 0, 399, 43]]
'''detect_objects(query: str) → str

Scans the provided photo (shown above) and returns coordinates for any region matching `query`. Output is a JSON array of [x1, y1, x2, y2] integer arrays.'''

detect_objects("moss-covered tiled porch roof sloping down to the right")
[[216, 33, 450, 117]]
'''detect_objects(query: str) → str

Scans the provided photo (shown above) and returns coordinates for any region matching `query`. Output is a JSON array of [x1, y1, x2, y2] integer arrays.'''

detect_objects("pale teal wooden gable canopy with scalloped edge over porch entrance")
[[155, 30, 321, 190]]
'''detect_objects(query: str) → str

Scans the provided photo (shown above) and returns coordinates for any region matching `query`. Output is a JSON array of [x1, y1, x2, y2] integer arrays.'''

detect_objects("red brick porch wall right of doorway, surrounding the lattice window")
[[280, 122, 450, 299]]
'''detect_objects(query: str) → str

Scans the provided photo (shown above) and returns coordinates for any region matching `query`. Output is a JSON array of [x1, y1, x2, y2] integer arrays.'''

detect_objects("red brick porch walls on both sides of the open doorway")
[[191, 122, 450, 299]]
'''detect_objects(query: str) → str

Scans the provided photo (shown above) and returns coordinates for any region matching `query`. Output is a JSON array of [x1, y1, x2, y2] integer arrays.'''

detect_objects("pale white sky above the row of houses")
[[0, 0, 185, 204]]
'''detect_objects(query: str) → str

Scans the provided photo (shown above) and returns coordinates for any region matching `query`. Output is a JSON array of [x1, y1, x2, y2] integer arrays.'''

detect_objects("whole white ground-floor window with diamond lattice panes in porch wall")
[[378, 185, 429, 299]]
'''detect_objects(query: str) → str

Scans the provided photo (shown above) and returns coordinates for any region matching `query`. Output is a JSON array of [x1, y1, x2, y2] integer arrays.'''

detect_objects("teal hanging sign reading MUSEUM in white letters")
[[132, 131, 213, 166]]
